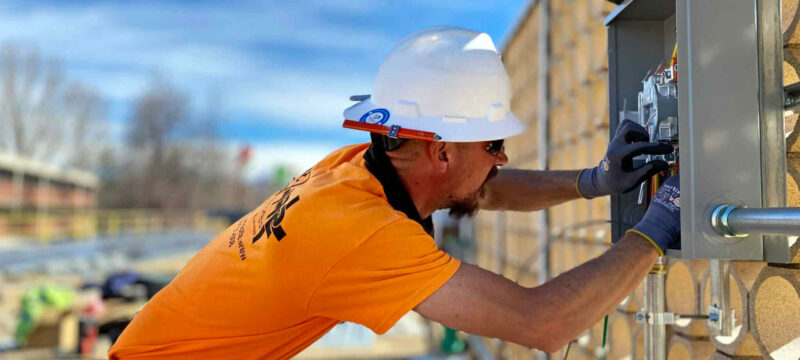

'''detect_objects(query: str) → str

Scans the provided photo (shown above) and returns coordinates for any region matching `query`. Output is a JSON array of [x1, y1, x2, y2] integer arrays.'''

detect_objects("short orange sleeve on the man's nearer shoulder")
[[308, 219, 461, 334]]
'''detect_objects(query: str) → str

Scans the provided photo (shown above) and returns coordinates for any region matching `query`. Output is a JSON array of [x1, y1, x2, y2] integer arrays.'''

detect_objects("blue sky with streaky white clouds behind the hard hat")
[[0, 0, 528, 177]]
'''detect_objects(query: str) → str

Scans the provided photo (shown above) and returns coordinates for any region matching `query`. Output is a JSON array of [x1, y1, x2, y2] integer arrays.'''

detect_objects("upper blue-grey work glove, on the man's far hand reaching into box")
[[576, 120, 673, 199]]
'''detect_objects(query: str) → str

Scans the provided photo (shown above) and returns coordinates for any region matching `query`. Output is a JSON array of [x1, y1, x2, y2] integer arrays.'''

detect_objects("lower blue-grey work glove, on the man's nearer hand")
[[626, 175, 681, 256]]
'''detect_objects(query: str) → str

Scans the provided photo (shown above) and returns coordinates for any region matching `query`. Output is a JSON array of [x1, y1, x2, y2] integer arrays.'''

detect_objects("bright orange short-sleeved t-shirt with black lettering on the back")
[[109, 144, 460, 359]]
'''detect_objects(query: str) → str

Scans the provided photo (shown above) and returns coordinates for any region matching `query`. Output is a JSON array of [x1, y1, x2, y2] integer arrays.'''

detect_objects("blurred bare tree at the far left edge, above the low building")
[[0, 44, 105, 168]]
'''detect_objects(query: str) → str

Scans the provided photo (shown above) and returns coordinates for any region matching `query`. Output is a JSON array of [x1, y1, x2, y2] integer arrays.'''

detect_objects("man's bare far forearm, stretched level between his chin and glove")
[[480, 169, 580, 211]]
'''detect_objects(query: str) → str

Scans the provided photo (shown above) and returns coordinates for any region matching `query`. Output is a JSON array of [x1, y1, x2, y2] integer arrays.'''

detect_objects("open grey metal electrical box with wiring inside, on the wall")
[[606, 0, 790, 262]]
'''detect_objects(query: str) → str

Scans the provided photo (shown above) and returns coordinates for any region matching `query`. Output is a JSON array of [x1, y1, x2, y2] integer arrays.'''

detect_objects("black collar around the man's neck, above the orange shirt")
[[364, 142, 433, 234]]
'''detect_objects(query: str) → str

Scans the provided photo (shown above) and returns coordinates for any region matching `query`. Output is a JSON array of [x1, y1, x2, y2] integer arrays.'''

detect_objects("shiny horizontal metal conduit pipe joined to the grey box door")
[[711, 204, 800, 237]]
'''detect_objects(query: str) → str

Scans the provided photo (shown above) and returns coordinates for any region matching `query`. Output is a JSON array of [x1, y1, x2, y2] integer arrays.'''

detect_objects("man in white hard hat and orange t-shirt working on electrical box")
[[110, 27, 679, 359]]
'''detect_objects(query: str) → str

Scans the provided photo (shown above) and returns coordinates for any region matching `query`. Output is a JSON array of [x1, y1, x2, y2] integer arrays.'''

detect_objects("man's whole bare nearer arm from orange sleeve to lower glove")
[[414, 233, 658, 352]]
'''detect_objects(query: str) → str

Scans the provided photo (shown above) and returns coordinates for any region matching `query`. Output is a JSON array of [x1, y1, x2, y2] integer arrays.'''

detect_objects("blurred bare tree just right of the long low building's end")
[[101, 78, 230, 211]]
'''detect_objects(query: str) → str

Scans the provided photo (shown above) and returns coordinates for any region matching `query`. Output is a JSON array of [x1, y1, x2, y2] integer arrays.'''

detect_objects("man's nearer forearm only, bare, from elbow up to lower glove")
[[530, 234, 658, 348]]
